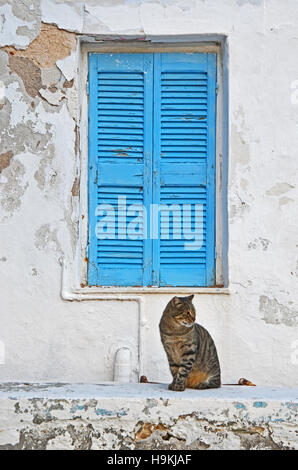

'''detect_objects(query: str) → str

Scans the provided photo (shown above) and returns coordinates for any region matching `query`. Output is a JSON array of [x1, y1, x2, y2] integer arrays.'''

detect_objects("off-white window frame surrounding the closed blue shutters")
[[74, 38, 228, 293]]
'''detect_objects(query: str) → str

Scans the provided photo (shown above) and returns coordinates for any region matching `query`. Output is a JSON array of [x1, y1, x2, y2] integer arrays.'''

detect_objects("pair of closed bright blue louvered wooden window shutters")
[[88, 52, 216, 287]]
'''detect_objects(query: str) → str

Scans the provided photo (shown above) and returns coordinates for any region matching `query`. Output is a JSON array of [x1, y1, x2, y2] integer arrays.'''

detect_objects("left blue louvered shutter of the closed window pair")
[[88, 54, 153, 286]]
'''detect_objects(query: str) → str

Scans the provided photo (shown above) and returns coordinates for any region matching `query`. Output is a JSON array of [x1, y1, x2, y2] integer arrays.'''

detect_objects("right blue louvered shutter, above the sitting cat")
[[153, 53, 216, 286]]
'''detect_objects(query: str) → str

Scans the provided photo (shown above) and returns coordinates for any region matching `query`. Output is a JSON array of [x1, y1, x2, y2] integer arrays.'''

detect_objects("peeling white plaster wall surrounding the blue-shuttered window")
[[0, 0, 298, 386]]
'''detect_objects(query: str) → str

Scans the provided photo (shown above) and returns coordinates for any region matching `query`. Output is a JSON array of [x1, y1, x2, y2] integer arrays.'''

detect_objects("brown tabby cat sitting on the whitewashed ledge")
[[159, 295, 221, 392]]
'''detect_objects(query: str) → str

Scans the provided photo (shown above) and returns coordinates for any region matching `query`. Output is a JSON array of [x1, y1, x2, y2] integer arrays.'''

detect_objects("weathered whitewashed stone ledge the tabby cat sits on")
[[0, 383, 298, 450]]
